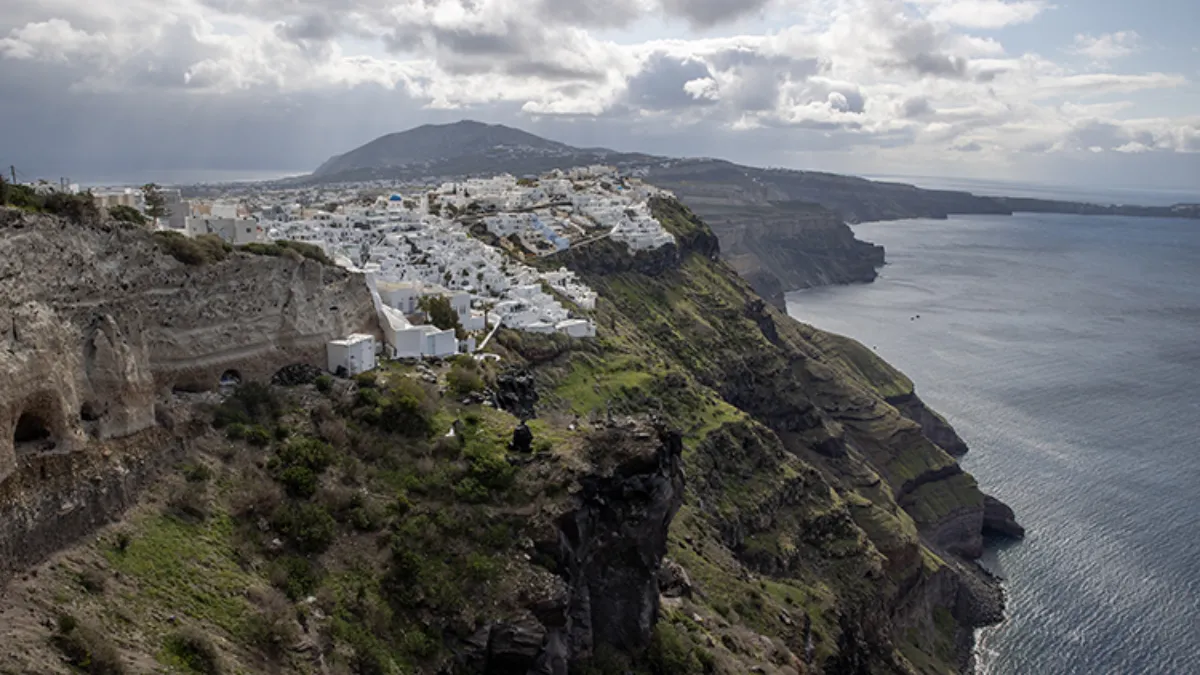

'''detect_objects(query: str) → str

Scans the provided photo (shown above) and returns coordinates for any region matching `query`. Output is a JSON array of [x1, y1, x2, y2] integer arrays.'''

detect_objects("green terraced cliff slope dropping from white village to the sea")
[[521, 201, 1018, 673]]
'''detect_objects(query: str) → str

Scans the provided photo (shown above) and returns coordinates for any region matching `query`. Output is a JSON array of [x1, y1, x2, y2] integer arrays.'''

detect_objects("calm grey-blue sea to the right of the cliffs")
[[788, 215, 1200, 675]]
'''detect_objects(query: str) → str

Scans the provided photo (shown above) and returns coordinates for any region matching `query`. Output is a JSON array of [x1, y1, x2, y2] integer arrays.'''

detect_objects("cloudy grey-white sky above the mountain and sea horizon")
[[0, 0, 1200, 189]]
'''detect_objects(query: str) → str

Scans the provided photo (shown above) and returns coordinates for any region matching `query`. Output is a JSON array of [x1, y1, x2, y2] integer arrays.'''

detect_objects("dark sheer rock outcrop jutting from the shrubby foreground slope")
[[458, 420, 684, 675]]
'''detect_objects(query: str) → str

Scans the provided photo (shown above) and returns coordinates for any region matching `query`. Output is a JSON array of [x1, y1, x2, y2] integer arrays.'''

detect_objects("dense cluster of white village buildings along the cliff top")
[[87, 166, 674, 376]]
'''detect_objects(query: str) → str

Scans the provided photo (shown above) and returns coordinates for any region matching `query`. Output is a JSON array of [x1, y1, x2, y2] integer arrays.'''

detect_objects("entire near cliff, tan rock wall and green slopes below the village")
[[0, 201, 1019, 675]]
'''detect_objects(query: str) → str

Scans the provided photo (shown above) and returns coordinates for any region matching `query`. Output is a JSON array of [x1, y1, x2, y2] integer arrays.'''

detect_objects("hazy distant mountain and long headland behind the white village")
[[307, 121, 1200, 304]]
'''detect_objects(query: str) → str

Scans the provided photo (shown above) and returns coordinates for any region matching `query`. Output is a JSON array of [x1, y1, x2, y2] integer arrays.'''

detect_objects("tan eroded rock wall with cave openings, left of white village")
[[0, 209, 376, 482]]
